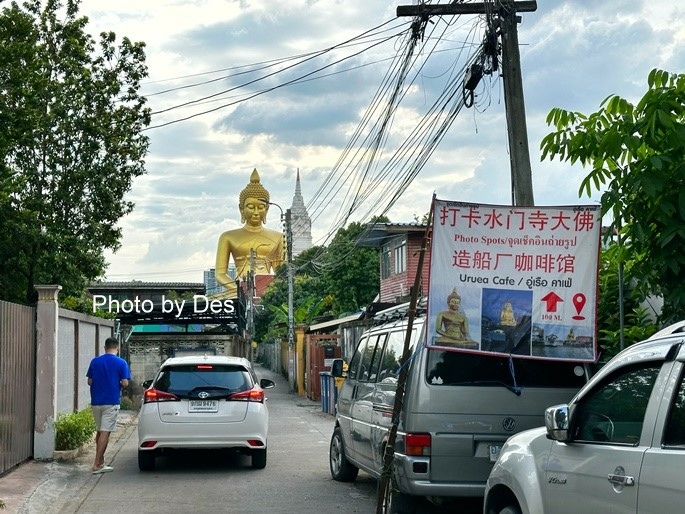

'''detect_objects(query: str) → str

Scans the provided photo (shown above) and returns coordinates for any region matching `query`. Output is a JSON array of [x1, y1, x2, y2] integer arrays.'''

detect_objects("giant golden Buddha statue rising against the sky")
[[214, 169, 283, 295]]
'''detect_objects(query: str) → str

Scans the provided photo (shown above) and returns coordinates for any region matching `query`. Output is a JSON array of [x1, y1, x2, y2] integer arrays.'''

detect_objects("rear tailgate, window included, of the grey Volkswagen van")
[[405, 349, 589, 485]]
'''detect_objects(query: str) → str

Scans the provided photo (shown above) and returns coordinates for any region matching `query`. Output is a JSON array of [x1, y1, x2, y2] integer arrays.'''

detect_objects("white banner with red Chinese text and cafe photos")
[[427, 199, 601, 361]]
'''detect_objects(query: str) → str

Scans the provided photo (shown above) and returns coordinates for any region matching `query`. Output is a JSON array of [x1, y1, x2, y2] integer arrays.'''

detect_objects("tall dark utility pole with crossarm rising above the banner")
[[397, 0, 537, 206]]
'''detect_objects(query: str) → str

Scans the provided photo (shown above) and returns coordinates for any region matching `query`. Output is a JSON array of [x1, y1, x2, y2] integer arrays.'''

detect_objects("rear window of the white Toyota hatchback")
[[154, 364, 252, 396]]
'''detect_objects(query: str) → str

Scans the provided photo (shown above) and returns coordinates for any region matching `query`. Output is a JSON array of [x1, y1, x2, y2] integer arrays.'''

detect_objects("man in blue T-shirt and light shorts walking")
[[86, 337, 131, 475]]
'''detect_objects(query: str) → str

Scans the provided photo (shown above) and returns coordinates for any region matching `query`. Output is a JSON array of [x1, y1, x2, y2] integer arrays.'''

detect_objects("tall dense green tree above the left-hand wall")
[[0, 0, 150, 302]]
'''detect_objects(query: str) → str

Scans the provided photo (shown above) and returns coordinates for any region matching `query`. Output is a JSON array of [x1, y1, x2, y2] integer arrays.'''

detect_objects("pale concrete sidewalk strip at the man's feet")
[[0, 411, 137, 514]]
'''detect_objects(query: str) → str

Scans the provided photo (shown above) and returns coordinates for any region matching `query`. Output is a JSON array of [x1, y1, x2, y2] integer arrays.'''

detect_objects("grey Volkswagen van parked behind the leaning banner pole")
[[329, 302, 590, 513]]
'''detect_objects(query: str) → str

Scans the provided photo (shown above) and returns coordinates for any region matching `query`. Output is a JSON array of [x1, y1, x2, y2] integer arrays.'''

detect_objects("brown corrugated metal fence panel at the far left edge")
[[0, 301, 36, 475]]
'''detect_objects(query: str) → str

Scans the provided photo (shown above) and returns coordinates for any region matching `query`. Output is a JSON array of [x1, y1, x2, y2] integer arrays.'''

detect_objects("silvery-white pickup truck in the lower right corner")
[[483, 322, 685, 514]]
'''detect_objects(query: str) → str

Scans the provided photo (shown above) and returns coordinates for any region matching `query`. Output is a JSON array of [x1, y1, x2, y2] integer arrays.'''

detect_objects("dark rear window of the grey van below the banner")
[[426, 350, 587, 388]]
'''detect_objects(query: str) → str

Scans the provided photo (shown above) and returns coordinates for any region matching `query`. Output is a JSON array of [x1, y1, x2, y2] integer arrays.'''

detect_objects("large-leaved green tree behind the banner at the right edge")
[[541, 69, 685, 323]]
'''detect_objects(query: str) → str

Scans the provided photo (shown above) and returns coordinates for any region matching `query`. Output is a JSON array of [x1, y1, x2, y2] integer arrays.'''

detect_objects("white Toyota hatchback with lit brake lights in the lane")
[[138, 355, 275, 471]]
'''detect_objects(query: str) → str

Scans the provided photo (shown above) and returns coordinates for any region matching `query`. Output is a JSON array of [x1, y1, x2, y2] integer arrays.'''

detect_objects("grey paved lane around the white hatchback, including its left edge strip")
[[0, 367, 376, 514]]
